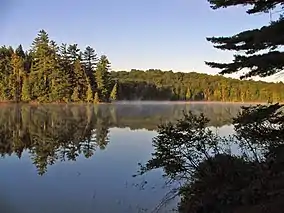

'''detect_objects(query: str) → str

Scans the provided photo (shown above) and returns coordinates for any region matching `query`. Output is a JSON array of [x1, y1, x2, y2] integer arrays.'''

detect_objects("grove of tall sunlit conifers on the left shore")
[[0, 30, 116, 102]]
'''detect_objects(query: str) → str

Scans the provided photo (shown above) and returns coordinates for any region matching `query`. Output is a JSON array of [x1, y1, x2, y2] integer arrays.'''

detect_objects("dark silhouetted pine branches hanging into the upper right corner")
[[206, 0, 284, 78]]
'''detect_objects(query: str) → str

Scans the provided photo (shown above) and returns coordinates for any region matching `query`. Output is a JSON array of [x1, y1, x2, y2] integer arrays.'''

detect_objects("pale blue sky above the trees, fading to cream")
[[0, 0, 280, 81]]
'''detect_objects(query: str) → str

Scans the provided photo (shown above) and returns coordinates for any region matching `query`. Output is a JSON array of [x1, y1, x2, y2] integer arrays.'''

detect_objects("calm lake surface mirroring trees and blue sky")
[[0, 103, 244, 213]]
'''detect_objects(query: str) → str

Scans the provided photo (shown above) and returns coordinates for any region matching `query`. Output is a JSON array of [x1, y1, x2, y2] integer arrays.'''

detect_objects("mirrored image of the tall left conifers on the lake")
[[0, 105, 110, 175]]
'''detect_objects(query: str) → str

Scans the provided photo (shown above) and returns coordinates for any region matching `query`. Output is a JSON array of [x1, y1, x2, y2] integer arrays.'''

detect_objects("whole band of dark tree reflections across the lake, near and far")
[[0, 104, 242, 175]]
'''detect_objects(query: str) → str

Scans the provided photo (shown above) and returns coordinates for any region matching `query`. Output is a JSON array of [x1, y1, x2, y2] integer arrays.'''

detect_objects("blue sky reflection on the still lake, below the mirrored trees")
[[0, 128, 175, 213]]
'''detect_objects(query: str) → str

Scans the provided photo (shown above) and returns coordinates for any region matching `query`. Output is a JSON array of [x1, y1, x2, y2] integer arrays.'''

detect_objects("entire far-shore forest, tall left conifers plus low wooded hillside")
[[0, 30, 284, 103]]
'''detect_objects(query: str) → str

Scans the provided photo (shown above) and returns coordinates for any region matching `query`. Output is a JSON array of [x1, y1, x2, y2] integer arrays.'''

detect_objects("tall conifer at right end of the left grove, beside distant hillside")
[[96, 55, 111, 101]]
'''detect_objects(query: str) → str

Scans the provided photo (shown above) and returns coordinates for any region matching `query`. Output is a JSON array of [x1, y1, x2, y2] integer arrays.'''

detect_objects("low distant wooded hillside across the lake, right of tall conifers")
[[111, 70, 284, 102]]
